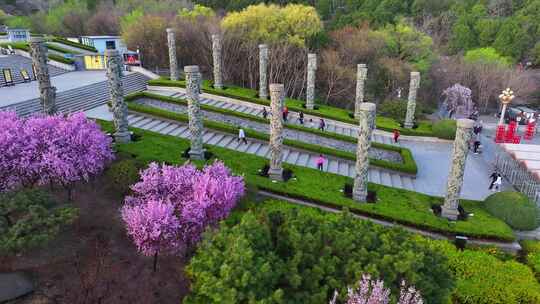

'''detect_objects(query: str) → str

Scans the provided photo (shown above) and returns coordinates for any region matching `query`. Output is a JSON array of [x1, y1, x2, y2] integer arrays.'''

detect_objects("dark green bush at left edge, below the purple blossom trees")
[[0, 190, 78, 253]]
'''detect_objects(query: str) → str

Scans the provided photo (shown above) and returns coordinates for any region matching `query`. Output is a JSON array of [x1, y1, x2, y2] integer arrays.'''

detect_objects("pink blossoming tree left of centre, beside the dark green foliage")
[[121, 161, 244, 269]]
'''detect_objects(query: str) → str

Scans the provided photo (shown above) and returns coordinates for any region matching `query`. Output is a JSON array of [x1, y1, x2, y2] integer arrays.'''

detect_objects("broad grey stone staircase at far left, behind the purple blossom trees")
[[0, 73, 149, 116]]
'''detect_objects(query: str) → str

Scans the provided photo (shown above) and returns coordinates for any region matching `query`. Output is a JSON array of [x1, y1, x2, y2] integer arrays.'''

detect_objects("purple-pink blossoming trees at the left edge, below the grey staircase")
[[0, 112, 114, 195]]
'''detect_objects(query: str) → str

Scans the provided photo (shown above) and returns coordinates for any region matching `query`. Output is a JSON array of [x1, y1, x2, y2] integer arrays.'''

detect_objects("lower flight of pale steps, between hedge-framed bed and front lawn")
[[128, 112, 421, 191]]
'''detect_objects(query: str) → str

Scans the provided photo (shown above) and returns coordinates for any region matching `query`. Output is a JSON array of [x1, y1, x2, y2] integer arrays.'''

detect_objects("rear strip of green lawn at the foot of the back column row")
[[148, 78, 433, 136]]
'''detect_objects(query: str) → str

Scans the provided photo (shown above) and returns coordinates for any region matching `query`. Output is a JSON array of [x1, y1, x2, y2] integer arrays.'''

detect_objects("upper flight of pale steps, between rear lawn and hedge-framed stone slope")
[[147, 89, 399, 146]]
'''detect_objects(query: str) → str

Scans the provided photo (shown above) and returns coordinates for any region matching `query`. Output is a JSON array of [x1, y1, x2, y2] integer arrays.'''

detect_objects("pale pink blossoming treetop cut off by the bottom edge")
[[330, 274, 424, 304]]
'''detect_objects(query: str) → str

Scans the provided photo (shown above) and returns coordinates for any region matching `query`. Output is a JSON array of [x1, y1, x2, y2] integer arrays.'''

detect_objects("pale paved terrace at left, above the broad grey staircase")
[[0, 71, 107, 108]]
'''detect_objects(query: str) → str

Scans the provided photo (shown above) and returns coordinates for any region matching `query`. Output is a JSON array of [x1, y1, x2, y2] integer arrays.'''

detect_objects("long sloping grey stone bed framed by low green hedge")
[[135, 98, 403, 162]]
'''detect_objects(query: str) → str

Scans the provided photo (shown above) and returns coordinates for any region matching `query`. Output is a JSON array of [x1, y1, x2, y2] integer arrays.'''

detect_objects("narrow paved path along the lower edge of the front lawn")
[[259, 190, 521, 253]]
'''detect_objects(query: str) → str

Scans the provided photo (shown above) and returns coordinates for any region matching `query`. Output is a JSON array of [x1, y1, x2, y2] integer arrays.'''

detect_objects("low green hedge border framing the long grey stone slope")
[[125, 92, 418, 175]]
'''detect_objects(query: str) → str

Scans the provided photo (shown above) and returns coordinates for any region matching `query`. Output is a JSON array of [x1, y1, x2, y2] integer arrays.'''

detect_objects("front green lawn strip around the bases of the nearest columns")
[[102, 122, 514, 241]]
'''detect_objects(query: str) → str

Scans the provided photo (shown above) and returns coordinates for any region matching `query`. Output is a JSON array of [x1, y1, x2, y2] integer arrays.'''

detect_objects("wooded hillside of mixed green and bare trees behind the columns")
[[0, 0, 540, 109]]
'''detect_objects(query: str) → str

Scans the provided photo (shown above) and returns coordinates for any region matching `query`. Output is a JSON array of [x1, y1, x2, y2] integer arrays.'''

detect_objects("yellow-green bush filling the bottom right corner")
[[424, 239, 540, 304]]
